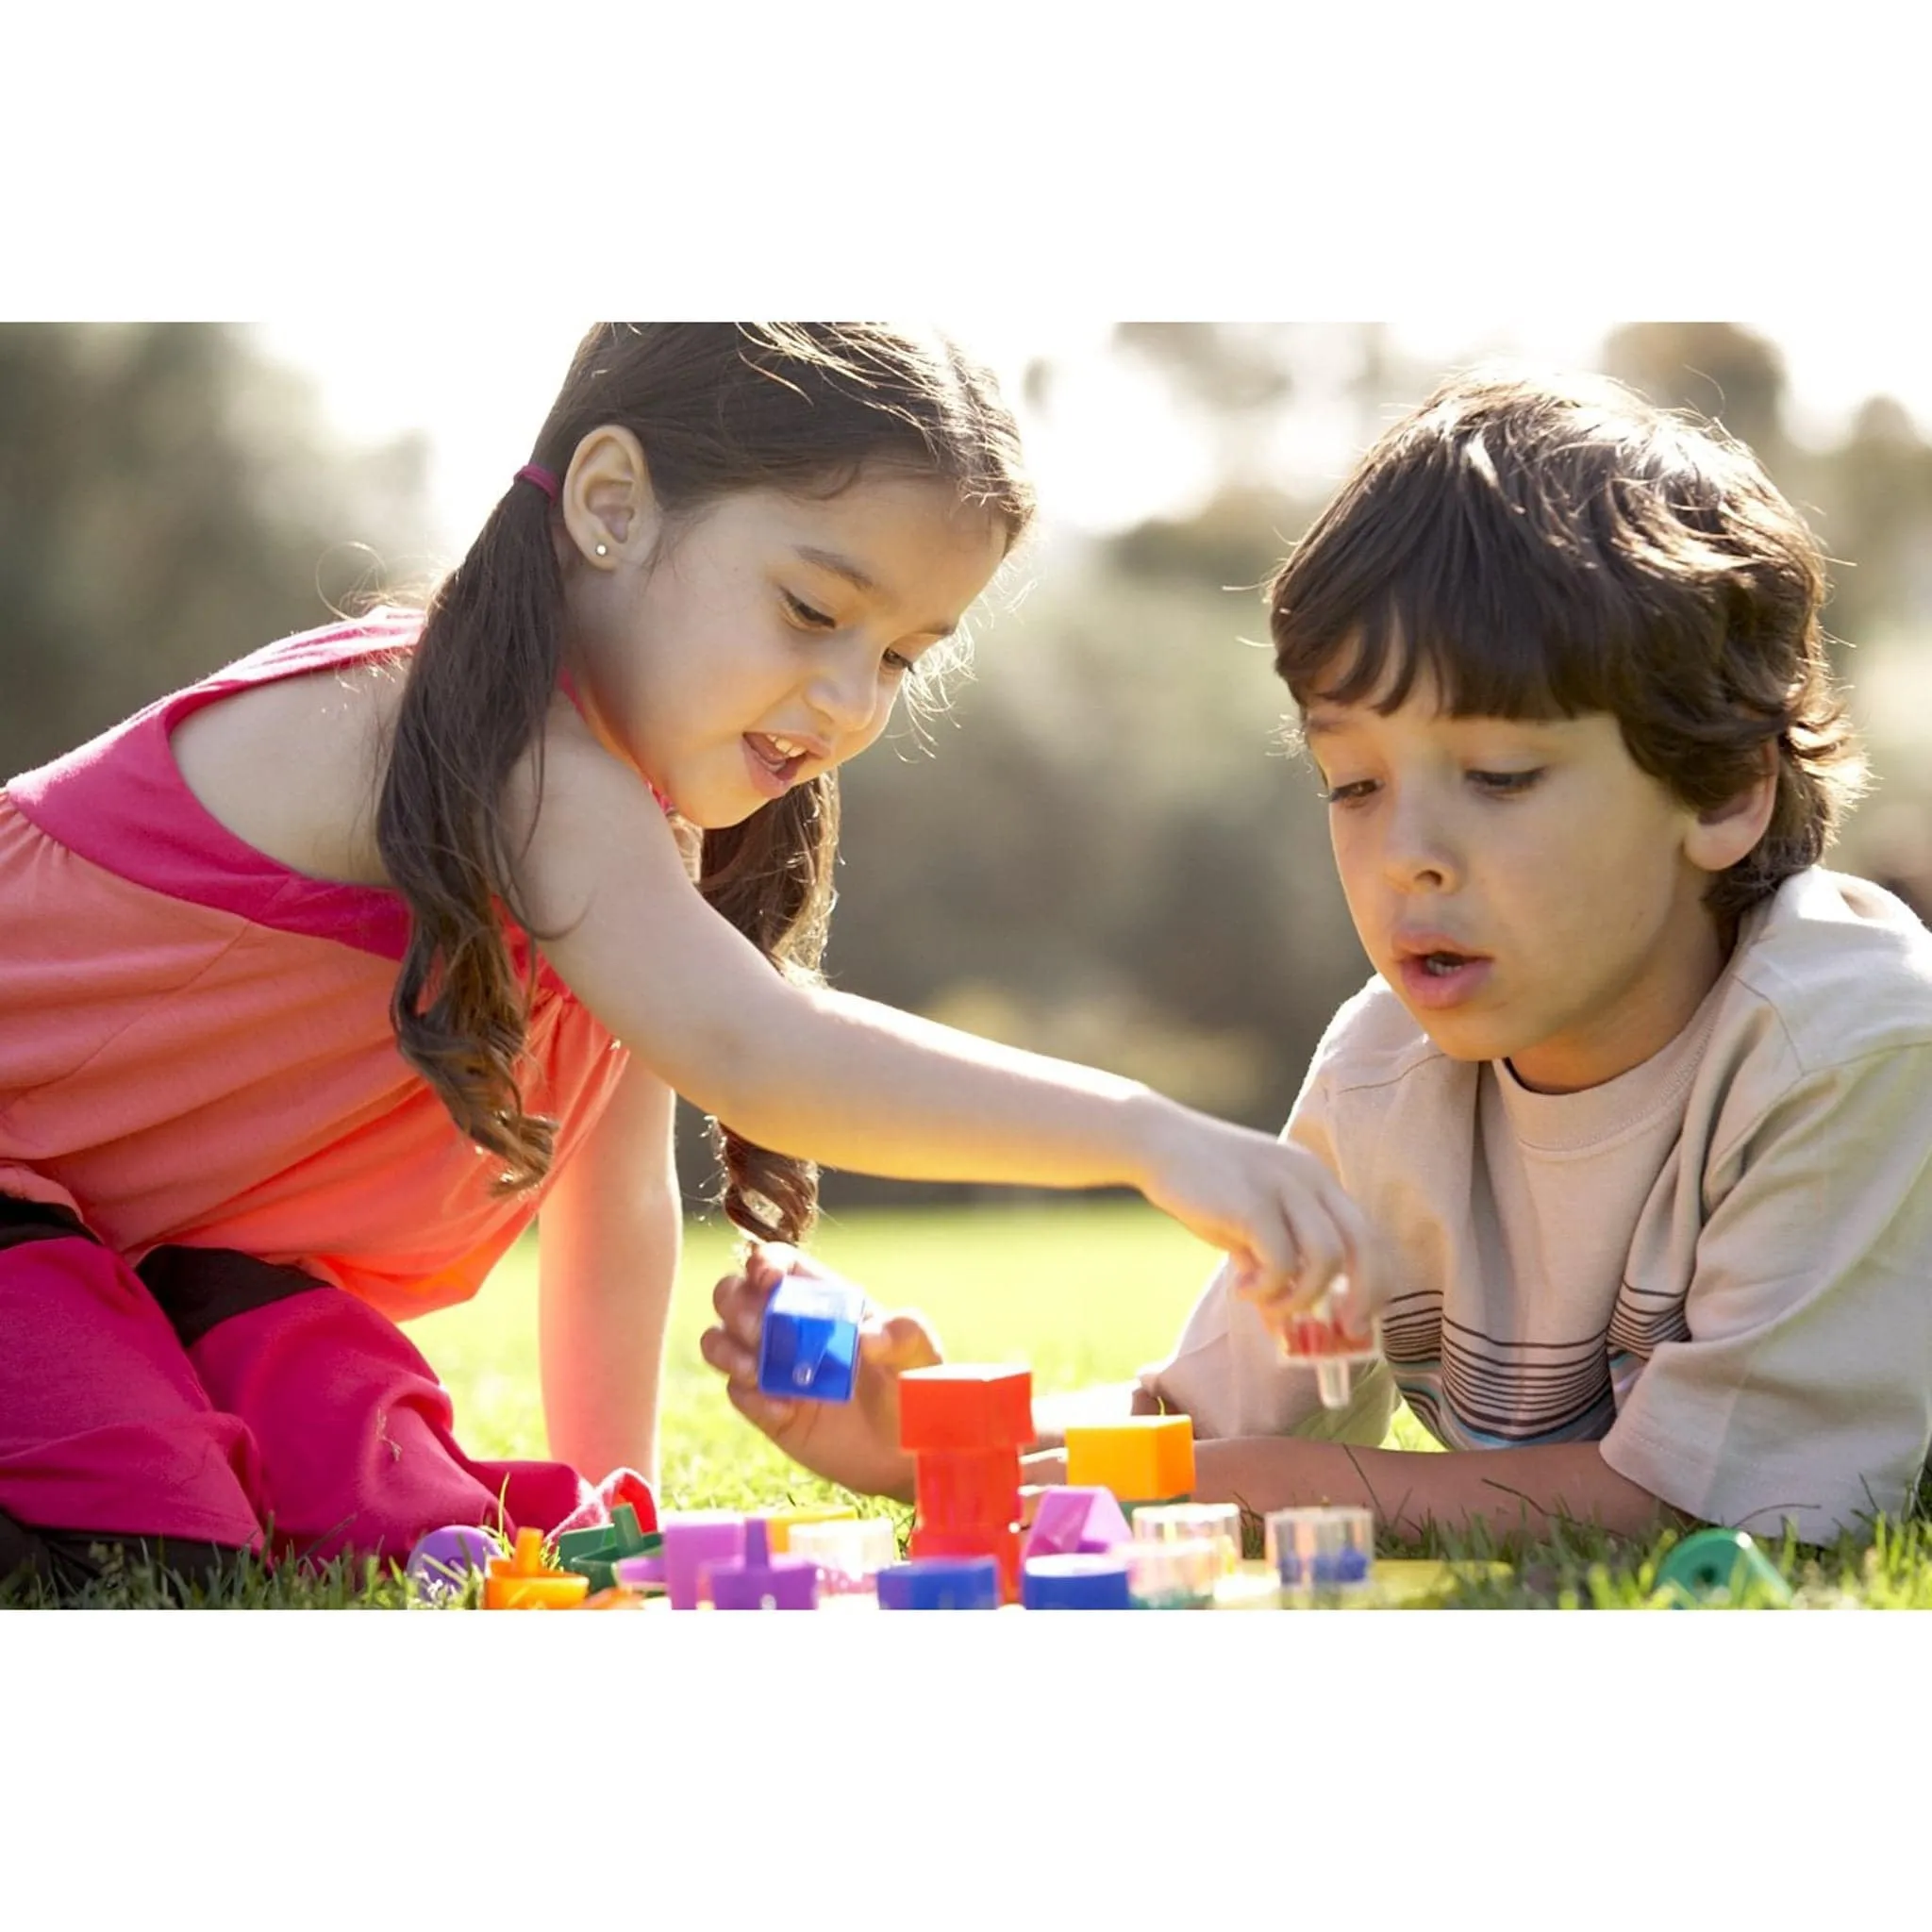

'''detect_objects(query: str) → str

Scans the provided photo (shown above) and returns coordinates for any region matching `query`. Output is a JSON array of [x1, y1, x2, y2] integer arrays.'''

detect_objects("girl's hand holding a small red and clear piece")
[[1141, 1108, 1385, 1333]]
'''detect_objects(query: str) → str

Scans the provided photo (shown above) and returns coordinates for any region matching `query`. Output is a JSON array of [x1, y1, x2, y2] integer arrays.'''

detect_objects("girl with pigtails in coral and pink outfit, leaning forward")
[[0, 323, 1360, 1571]]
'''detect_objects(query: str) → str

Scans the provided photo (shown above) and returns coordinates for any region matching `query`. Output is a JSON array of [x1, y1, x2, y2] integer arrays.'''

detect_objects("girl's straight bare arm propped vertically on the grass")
[[537, 1060, 682, 1484]]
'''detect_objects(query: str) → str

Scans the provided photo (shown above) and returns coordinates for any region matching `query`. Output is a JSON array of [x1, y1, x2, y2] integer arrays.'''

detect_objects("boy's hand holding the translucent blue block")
[[697, 1242, 941, 1503]]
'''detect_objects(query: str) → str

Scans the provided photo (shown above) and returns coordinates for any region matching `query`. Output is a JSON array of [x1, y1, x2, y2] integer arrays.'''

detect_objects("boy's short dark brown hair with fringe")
[[1267, 371, 1864, 920]]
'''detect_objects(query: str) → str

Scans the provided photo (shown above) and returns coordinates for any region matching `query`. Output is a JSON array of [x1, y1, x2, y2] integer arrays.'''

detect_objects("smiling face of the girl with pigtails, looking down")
[[572, 470, 1007, 829]]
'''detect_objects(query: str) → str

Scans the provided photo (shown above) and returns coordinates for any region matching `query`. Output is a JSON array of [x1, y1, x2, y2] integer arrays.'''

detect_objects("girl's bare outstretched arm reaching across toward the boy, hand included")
[[518, 728, 1374, 1312]]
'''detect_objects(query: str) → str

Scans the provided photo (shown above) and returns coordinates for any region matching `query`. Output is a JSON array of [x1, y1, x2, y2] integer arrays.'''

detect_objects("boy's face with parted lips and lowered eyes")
[[1304, 675, 1724, 1091]]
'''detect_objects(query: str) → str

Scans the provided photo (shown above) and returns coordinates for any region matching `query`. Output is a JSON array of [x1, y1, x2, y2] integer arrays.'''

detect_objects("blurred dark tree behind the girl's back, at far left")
[[0, 323, 427, 778]]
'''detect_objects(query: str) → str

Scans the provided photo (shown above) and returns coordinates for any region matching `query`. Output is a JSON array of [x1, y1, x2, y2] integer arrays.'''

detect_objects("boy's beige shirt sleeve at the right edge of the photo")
[[1604, 1043, 1932, 1541]]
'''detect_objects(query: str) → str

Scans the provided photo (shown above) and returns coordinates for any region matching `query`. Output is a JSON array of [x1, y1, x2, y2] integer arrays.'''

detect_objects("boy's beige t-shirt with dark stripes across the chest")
[[1141, 870, 1932, 1540]]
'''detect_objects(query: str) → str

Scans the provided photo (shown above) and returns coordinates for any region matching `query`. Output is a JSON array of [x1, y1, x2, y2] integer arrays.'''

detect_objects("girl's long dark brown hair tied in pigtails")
[[376, 323, 1034, 1241]]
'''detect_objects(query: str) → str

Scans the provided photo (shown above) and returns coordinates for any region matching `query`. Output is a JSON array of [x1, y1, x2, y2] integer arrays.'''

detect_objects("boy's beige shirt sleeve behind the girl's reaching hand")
[[1140, 1057, 1395, 1447]]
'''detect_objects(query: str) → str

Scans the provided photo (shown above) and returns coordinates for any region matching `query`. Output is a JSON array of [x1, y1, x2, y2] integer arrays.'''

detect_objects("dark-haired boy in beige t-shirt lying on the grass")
[[703, 373, 1932, 1541]]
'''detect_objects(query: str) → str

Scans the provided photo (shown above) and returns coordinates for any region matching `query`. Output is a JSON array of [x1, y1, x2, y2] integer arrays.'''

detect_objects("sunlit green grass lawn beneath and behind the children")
[[0, 1202, 1932, 1609]]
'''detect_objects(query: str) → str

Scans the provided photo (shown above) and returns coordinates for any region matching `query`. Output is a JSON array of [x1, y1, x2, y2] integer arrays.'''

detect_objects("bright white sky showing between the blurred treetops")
[[258, 309, 1932, 555]]
